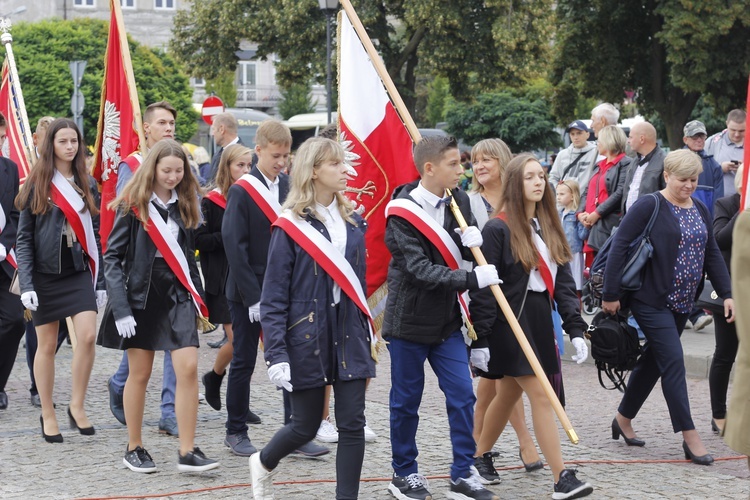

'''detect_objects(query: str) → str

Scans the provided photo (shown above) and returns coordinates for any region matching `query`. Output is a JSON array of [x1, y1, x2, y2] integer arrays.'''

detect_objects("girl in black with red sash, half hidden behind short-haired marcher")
[[195, 144, 253, 410]]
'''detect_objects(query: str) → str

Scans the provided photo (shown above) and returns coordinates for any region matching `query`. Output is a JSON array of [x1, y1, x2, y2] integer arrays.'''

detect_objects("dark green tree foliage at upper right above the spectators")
[[553, 0, 750, 148]]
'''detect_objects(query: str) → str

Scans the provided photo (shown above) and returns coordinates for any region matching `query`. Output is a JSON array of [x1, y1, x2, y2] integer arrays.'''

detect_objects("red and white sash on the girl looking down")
[[133, 203, 208, 318]]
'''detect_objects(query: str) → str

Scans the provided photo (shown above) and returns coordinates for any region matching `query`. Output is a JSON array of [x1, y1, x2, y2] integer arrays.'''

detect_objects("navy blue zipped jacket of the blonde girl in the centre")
[[260, 214, 375, 390]]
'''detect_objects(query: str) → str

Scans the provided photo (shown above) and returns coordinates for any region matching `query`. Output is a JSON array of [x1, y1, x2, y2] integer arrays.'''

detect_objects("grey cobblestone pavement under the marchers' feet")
[[0, 318, 750, 500]]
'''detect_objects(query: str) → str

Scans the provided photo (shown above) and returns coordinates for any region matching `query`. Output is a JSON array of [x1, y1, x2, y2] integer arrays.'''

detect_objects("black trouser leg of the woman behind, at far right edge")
[[708, 314, 739, 418]]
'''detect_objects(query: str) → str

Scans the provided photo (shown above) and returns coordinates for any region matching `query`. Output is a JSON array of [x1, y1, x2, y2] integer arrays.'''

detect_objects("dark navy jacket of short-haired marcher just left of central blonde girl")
[[221, 166, 289, 307]]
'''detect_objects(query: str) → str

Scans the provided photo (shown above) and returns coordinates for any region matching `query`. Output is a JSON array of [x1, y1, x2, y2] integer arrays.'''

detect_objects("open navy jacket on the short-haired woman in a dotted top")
[[602, 192, 732, 307]]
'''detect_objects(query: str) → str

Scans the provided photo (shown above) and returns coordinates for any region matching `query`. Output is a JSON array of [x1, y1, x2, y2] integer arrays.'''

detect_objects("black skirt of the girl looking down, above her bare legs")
[[97, 258, 198, 351]]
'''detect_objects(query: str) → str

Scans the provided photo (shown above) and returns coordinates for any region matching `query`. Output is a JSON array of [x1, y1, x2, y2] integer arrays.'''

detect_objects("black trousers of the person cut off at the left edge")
[[0, 269, 25, 391]]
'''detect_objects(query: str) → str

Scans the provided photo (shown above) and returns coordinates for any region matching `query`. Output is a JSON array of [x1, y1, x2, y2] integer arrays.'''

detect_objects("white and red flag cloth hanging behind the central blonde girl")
[[339, 12, 419, 300]]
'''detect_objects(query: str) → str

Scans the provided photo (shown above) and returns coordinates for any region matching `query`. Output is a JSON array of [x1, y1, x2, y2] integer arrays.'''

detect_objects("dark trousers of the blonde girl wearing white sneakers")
[[260, 378, 367, 500]]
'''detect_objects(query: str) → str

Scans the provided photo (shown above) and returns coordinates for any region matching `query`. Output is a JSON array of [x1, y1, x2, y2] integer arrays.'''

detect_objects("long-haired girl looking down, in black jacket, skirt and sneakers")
[[99, 139, 219, 473]]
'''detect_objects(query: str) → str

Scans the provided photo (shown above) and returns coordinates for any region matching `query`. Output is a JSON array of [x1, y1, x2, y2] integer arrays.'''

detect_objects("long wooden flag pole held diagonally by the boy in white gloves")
[[340, 0, 578, 444]]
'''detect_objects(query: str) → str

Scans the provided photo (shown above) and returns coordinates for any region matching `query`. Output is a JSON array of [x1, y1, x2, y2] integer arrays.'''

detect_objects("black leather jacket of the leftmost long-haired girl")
[[16, 177, 105, 293]]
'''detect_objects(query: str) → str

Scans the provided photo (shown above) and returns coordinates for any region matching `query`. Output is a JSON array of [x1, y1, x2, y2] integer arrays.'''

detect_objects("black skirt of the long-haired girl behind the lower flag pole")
[[482, 291, 560, 379]]
